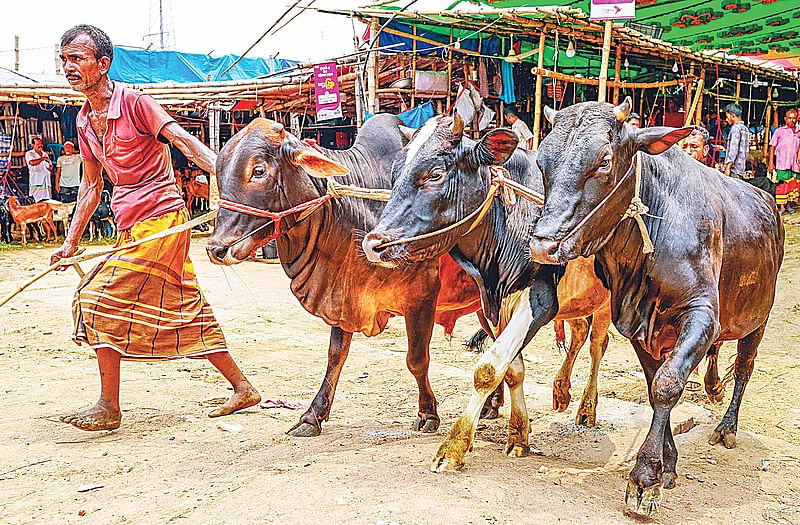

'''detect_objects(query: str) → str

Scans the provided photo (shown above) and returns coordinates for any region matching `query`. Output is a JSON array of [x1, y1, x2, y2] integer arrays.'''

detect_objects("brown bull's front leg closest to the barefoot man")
[[287, 327, 353, 437]]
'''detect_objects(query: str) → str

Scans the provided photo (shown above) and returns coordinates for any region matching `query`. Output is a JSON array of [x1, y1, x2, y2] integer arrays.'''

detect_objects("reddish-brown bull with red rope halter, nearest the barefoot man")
[[207, 115, 480, 436]]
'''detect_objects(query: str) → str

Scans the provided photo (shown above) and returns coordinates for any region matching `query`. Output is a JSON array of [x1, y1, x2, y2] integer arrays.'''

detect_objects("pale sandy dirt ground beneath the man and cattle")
[[0, 226, 800, 524]]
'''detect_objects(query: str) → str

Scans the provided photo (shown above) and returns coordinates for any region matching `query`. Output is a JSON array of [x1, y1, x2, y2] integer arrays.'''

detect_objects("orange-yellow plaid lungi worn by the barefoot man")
[[72, 209, 227, 360]]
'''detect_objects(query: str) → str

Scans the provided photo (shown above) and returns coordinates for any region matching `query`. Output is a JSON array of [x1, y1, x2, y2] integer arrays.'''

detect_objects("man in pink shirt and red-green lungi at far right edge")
[[767, 109, 800, 215]]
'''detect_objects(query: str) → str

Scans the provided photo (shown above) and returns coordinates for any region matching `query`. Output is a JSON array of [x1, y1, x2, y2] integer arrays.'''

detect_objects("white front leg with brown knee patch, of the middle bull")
[[431, 277, 558, 472]]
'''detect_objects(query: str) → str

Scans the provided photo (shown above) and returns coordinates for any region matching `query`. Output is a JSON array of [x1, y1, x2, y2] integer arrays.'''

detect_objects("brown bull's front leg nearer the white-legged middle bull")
[[405, 301, 439, 433]]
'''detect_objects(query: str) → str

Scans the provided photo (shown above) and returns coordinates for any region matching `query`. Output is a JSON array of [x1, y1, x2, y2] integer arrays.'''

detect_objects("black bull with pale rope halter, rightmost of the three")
[[531, 99, 784, 515]]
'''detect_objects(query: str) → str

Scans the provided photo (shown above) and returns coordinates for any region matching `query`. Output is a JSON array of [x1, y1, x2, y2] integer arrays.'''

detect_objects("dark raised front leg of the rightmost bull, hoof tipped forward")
[[625, 306, 719, 516]]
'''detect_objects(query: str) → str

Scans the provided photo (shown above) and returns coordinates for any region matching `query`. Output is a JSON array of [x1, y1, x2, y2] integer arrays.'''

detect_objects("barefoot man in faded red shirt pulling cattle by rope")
[[51, 25, 261, 430]]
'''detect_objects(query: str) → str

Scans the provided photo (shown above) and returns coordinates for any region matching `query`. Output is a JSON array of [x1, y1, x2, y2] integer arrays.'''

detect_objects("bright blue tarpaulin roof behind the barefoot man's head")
[[109, 47, 299, 84]]
